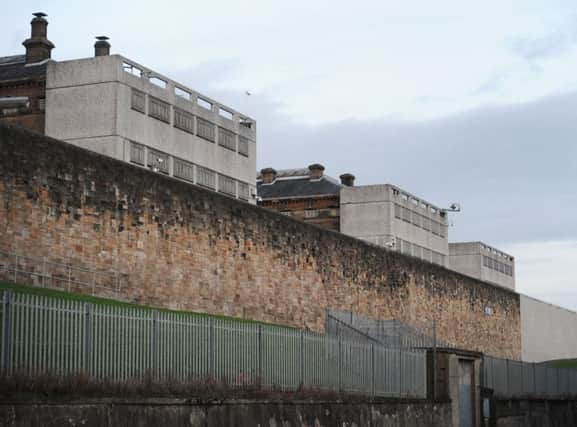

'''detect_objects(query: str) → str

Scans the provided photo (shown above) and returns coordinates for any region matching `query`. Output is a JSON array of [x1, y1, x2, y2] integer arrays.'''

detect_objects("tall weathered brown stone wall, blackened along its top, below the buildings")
[[0, 125, 521, 359]]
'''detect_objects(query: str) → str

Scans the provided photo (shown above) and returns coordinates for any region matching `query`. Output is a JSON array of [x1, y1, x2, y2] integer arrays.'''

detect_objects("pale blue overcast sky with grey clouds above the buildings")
[[0, 0, 577, 310]]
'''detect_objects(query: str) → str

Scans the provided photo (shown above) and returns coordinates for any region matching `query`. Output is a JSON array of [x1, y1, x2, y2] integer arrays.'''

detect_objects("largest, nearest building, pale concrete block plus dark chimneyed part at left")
[[0, 14, 256, 203]]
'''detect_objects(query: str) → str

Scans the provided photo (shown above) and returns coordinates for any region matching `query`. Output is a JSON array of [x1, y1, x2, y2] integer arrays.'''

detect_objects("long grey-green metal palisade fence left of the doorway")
[[1, 291, 426, 398]]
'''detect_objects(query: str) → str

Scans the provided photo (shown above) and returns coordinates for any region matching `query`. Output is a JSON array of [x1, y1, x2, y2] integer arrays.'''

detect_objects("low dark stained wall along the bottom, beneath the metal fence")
[[0, 399, 451, 427]]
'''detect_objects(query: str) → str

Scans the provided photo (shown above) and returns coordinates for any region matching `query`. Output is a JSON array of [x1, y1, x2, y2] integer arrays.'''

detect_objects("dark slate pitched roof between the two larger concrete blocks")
[[257, 168, 342, 199]]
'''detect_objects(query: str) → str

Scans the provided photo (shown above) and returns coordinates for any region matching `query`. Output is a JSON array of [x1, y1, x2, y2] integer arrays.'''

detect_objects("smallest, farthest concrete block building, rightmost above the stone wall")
[[449, 242, 515, 289]]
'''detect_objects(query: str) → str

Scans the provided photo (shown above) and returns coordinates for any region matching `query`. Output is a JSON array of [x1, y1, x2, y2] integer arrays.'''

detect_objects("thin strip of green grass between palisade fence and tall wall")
[[0, 282, 280, 329]]
